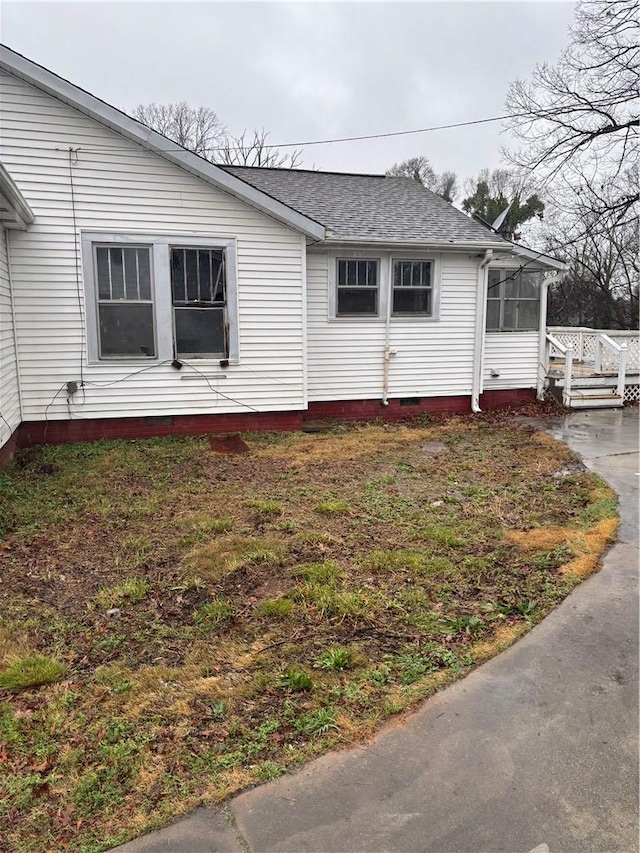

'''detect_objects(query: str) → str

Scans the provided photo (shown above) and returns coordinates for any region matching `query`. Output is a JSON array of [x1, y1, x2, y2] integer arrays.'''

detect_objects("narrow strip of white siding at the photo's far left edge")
[[0, 225, 20, 447]]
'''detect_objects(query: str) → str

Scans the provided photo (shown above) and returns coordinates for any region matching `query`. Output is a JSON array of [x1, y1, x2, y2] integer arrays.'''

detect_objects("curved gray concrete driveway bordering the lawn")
[[118, 408, 640, 853]]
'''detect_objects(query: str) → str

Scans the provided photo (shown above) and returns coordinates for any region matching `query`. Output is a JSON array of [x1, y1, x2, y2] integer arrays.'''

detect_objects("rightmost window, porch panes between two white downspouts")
[[487, 268, 542, 332]]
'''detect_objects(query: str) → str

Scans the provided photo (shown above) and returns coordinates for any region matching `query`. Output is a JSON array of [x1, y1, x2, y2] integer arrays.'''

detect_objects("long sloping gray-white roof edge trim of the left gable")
[[0, 45, 325, 240]]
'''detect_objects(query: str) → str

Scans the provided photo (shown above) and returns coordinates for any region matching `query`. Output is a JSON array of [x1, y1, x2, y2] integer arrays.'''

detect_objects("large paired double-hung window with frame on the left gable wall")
[[82, 232, 239, 364]]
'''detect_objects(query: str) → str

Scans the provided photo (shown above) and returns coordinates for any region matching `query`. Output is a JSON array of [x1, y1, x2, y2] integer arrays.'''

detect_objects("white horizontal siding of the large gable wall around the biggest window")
[[0, 68, 305, 420]]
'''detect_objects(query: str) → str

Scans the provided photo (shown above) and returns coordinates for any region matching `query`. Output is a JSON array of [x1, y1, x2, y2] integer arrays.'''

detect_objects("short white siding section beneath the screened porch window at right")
[[483, 332, 538, 391]]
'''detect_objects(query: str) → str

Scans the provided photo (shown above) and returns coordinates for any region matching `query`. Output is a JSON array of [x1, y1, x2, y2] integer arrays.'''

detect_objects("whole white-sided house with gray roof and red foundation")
[[0, 47, 562, 456]]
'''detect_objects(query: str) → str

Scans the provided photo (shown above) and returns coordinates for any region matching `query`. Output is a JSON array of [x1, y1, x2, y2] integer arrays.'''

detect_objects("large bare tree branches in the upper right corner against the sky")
[[507, 0, 640, 218]]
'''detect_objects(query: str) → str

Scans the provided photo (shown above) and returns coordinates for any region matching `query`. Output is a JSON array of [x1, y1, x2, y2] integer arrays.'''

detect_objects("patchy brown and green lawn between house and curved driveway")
[[0, 418, 617, 853]]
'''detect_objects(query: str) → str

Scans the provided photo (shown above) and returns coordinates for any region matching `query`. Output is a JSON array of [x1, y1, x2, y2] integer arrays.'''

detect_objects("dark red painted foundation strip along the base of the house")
[[0, 388, 535, 462]]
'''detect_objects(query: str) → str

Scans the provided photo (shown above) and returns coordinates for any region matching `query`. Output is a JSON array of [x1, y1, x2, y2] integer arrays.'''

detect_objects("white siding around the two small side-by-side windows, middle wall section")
[[307, 250, 478, 400]]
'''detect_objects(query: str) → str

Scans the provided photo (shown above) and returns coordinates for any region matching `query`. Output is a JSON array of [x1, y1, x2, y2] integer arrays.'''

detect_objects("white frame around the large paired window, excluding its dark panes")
[[81, 230, 240, 364]]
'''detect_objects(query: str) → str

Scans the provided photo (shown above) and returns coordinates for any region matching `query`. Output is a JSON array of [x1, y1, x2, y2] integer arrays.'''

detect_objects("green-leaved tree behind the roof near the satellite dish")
[[462, 169, 544, 240]]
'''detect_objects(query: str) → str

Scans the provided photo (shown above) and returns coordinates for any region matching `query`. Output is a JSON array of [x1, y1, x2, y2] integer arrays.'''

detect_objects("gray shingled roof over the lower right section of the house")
[[222, 166, 506, 244]]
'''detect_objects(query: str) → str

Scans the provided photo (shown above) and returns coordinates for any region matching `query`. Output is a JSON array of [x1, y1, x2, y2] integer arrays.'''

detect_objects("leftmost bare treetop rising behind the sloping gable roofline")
[[131, 101, 226, 160]]
